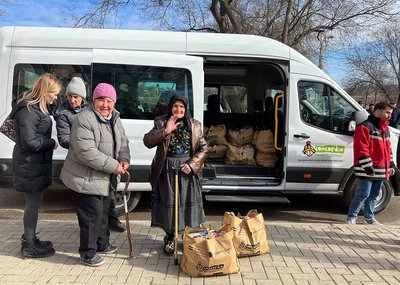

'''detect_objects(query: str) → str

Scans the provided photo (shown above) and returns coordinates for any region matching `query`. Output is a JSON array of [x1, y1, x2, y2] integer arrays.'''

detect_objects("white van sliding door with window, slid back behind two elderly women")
[[92, 49, 204, 185]]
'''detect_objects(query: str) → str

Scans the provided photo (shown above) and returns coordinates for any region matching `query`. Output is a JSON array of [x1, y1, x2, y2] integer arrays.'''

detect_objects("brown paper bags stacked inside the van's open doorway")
[[204, 125, 277, 167]]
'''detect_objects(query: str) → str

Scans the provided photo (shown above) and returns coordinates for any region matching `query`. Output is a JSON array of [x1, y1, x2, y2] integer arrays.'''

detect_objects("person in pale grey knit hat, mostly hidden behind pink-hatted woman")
[[53, 77, 126, 232]]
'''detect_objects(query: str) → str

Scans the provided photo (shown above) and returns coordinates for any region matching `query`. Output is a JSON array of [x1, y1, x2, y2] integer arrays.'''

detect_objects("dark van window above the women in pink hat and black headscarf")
[[92, 63, 193, 120]]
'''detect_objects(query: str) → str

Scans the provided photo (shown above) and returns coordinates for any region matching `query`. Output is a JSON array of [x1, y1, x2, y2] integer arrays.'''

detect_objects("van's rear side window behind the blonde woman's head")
[[12, 63, 90, 105]]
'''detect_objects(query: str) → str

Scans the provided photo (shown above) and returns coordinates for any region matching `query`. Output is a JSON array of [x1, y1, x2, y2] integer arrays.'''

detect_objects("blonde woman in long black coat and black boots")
[[10, 74, 61, 258]]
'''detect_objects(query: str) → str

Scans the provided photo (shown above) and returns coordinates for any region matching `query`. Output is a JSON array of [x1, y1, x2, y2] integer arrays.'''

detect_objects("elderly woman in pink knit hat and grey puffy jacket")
[[60, 83, 130, 266]]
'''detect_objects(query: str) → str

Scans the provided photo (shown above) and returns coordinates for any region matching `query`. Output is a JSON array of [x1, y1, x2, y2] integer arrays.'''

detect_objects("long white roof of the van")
[[0, 26, 329, 82]]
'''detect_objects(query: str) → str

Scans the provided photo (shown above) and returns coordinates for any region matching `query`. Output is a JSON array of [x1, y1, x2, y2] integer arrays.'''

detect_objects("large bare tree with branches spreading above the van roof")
[[74, 0, 399, 48]]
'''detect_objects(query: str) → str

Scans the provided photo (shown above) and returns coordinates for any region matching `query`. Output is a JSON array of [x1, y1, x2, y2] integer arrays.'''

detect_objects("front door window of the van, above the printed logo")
[[297, 81, 356, 134]]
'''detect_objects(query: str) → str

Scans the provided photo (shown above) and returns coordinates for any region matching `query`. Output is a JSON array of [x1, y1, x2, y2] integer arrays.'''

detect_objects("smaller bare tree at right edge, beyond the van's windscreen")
[[346, 25, 400, 103]]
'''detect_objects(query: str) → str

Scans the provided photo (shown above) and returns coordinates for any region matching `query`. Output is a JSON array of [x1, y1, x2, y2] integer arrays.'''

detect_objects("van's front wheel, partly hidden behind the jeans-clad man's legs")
[[344, 175, 393, 213]]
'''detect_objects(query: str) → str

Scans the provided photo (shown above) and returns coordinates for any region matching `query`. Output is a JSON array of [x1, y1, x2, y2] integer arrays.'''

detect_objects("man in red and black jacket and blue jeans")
[[346, 102, 394, 225]]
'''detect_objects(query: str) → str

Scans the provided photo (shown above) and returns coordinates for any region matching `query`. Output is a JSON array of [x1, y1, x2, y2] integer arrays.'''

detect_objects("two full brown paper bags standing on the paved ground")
[[181, 210, 270, 276]]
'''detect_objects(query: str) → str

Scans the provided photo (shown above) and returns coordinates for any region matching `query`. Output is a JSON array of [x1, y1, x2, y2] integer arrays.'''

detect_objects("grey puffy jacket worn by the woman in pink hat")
[[60, 106, 130, 196]]
